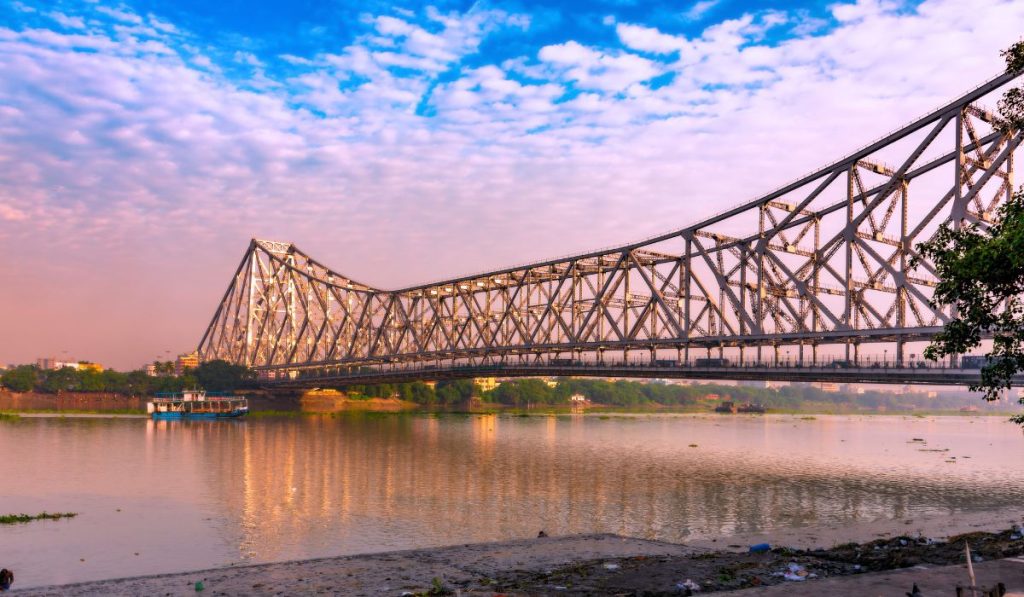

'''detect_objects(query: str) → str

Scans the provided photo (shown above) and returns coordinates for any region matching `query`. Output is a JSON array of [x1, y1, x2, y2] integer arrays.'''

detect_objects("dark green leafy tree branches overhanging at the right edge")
[[911, 41, 1024, 423]]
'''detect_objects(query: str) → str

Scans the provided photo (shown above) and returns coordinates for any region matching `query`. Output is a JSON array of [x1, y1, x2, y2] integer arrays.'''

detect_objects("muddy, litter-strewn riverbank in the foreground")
[[17, 528, 1024, 596]]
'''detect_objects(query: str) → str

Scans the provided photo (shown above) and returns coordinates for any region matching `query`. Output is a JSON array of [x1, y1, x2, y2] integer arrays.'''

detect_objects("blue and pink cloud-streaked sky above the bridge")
[[0, 0, 1024, 369]]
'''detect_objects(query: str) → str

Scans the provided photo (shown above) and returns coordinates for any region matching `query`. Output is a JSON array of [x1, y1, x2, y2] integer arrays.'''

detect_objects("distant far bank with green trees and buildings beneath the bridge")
[[0, 360, 1018, 415]]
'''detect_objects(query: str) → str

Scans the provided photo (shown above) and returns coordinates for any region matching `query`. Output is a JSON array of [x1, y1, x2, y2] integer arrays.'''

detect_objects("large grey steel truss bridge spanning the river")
[[199, 75, 1024, 386]]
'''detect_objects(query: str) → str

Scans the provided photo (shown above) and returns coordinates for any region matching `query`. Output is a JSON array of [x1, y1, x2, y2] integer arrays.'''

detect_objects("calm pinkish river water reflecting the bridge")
[[0, 414, 1024, 586]]
